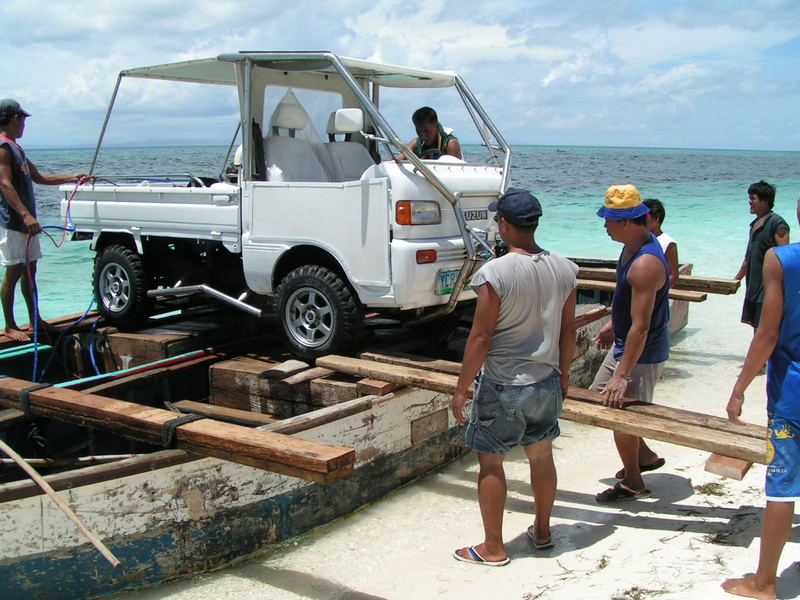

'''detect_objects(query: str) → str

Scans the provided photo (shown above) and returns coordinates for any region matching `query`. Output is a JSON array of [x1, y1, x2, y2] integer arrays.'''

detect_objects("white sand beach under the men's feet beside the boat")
[[122, 292, 800, 600]]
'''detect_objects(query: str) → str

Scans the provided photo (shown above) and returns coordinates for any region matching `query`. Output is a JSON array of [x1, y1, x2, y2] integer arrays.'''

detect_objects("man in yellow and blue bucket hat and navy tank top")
[[591, 185, 669, 502]]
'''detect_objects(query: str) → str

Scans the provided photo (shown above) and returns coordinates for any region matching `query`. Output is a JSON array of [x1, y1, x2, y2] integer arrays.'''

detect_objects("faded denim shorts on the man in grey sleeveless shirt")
[[466, 371, 564, 454]]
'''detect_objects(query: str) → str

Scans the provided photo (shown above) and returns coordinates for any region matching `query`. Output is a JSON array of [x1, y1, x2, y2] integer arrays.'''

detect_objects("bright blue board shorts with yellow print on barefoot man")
[[766, 414, 800, 502]]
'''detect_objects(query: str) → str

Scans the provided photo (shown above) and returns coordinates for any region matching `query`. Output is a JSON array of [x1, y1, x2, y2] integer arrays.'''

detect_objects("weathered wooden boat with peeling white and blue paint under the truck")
[[0, 264, 736, 600]]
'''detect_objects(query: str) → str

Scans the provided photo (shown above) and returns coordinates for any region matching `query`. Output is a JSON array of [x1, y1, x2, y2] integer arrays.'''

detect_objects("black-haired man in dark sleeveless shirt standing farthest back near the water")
[[734, 180, 789, 329]]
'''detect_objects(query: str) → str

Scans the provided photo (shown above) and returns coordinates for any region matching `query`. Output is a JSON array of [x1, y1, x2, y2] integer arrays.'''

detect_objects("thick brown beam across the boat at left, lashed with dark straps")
[[0, 378, 355, 483]]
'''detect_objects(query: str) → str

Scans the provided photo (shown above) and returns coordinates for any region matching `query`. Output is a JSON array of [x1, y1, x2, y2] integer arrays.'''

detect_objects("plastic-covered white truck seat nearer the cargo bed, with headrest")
[[264, 104, 331, 181]]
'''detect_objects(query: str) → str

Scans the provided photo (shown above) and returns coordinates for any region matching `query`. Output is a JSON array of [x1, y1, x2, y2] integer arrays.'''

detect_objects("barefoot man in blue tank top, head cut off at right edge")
[[722, 201, 800, 598]]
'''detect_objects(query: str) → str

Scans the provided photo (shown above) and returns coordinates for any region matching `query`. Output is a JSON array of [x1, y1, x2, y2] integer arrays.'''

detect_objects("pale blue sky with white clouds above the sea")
[[0, 0, 800, 151]]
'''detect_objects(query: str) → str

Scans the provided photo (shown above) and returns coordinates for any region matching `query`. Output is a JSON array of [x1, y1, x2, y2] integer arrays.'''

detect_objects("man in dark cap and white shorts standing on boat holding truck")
[[0, 98, 86, 342]]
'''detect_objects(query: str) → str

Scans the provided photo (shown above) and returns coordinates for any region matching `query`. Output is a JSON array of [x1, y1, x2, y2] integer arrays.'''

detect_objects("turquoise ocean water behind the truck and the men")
[[15, 146, 800, 323]]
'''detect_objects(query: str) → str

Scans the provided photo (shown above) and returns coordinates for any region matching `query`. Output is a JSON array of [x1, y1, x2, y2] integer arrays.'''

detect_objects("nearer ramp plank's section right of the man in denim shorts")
[[561, 398, 767, 464]]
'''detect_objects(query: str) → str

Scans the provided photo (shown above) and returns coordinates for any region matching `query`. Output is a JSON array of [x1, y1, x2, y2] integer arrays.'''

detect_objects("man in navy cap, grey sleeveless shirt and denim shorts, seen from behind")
[[451, 188, 578, 567]]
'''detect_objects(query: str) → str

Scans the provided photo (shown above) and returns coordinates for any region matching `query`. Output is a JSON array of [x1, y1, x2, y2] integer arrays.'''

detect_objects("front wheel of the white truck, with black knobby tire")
[[277, 265, 364, 359]]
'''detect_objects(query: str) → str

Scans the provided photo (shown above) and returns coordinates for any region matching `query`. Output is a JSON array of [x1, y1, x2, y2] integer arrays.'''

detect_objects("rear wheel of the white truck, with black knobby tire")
[[92, 246, 152, 326]]
